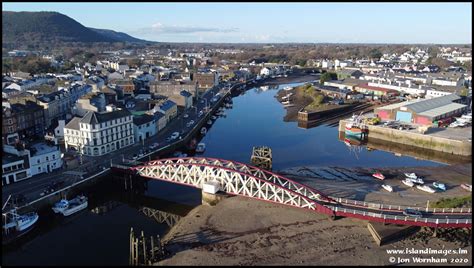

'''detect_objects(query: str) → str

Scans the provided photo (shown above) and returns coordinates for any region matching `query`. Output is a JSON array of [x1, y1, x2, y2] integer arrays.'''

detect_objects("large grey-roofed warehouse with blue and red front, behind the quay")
[[374, 94, 468, 126]]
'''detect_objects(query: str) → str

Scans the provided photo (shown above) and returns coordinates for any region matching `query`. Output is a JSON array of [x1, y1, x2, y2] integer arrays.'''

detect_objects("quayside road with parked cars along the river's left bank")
[[2, 81, 237, 209]]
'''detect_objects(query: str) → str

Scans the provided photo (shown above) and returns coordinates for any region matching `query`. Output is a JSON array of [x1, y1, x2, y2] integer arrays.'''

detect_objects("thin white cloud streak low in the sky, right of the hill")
[[137, 22, 239, 34]]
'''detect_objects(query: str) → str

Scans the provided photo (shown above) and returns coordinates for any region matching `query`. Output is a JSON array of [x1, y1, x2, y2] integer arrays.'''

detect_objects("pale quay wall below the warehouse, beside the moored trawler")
[[339, 120, 472, 156]]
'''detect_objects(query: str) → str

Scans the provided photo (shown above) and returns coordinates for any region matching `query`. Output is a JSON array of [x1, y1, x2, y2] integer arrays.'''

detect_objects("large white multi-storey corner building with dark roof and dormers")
[[64, 110, 134, 156]]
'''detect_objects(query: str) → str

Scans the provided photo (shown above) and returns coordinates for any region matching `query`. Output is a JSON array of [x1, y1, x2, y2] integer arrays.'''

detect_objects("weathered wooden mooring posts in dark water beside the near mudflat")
[[129, 228, 164, 266]]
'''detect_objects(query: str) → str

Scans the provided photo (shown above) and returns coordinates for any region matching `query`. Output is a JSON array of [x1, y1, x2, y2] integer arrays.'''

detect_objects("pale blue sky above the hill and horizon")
[[2, 2, 472, 44]]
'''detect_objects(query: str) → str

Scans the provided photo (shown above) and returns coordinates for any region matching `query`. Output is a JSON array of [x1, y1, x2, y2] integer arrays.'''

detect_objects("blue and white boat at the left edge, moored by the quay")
[[2, 208, 39, 245]]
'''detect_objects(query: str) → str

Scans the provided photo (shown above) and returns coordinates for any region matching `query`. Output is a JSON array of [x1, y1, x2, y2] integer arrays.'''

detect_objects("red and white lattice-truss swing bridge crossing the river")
[[112, 157, 472, 228]]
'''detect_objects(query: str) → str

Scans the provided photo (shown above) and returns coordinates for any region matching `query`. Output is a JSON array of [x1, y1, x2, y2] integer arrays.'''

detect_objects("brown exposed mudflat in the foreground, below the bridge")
[[157, 196, 472, 265]]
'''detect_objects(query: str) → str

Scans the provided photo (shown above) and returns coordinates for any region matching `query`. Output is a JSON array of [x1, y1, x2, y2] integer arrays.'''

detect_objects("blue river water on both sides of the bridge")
[[2, 84, 444, 265]]
